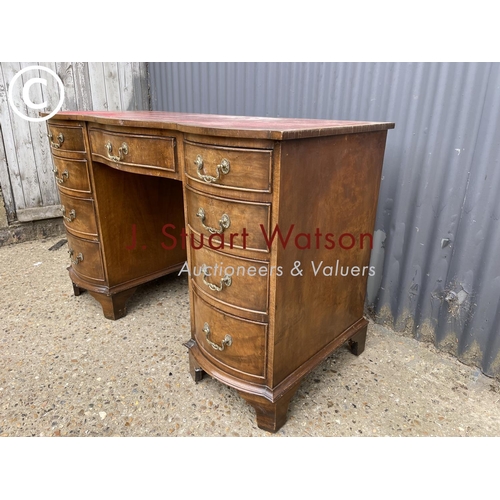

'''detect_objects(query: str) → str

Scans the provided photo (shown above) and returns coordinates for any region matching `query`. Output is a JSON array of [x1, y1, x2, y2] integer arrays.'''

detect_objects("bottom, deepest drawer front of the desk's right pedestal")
[[193, 293, 267, 378]]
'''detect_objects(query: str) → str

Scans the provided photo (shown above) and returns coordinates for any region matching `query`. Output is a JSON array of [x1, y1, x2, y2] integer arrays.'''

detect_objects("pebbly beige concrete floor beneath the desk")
[[0, 236, 500, 436]]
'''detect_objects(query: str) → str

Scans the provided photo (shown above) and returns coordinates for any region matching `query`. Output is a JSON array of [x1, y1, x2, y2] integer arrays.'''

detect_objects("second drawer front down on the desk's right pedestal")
[[186, 187, 271, 252]]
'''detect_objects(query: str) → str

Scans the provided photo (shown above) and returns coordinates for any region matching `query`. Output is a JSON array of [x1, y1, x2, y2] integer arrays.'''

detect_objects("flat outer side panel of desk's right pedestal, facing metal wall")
[[273, 131, 386, 384]]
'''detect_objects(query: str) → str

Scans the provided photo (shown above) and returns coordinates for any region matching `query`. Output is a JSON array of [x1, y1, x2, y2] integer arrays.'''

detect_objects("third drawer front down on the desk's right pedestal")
[[190, 241, 269, 314]]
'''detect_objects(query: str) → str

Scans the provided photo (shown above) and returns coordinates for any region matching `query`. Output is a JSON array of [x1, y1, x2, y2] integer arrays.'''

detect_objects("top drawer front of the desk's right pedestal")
[[184, 141, 273, 193]]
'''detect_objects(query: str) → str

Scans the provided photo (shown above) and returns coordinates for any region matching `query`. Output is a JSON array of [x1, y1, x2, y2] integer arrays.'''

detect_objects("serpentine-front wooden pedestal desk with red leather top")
[[48, 112, 394, 432]]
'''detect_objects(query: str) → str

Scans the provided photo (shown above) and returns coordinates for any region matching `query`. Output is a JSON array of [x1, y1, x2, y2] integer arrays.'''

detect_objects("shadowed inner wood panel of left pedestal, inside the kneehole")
[[92, 161, 186, 288]]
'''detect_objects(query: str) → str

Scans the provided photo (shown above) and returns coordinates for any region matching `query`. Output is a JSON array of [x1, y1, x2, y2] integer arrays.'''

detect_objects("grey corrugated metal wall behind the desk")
[[149, 63, 500, 376]]
